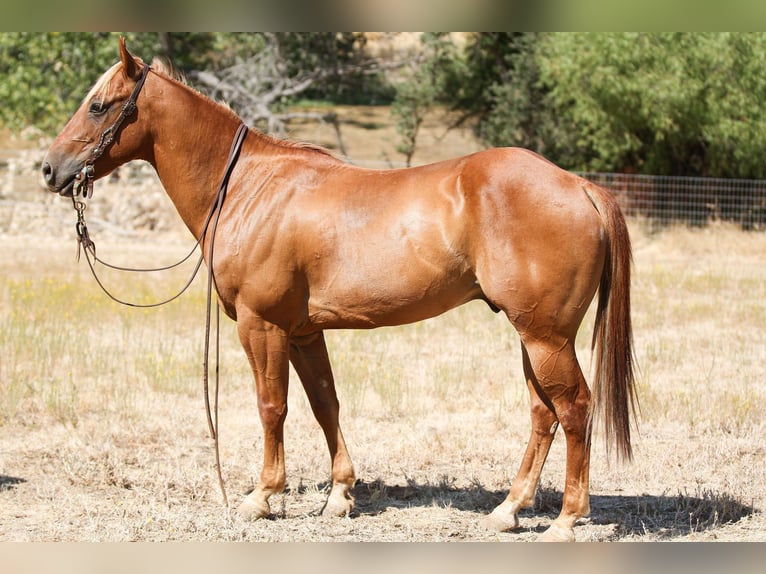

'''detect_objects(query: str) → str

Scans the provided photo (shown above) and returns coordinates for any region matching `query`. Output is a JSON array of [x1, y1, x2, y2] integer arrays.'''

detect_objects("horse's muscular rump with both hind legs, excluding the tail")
[[476, 165, 611, 540]]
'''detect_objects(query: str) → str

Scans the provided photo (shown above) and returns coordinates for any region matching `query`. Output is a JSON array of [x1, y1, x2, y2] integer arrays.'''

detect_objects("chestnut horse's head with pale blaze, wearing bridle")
[[42, 38, 149, 196]]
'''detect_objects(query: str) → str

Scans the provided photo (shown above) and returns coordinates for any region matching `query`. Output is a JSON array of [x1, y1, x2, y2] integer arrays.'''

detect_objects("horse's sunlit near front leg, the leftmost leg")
[[237, 314, 289, 520]]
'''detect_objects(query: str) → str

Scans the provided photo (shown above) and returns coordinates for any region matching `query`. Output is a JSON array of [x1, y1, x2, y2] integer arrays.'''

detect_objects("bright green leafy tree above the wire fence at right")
[[538, 33, 766, 178]]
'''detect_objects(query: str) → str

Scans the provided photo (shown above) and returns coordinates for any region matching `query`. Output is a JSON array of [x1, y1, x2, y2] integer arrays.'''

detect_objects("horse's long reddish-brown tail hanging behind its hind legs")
[[584, 183, 638, 461]]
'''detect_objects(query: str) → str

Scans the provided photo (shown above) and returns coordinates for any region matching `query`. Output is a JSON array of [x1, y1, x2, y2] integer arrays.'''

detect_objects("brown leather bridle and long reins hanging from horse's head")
[[72, 65, 248, 506]]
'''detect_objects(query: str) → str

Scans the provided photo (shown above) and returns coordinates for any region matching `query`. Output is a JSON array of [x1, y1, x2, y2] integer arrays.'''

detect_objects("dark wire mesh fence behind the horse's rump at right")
[[579, 172, 766, 231]]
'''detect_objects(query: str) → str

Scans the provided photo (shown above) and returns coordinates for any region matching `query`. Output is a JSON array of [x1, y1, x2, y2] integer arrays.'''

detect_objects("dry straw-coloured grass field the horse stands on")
[[0, 109, 766, 542]]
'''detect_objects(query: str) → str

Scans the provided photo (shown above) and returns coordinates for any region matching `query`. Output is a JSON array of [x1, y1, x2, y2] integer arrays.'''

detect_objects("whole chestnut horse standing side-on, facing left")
[[42, 40, 634, 540]]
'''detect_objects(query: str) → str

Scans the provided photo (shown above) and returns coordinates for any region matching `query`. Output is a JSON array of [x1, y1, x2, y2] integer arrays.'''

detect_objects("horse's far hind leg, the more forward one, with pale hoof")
[[483, 344, 558, 532]]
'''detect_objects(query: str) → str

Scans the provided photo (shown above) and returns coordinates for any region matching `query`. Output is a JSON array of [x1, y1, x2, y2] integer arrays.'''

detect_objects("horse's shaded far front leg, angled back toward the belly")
[[290, 332, 356, 516]]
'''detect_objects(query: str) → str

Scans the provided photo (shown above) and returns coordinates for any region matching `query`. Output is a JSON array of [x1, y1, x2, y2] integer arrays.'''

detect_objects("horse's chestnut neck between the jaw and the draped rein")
[[149, 82, 246, 237]]
